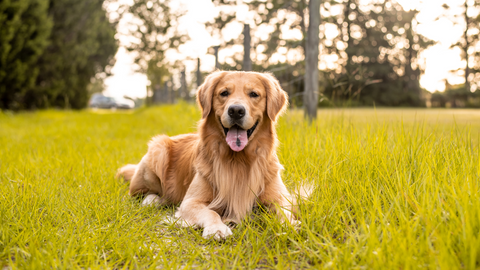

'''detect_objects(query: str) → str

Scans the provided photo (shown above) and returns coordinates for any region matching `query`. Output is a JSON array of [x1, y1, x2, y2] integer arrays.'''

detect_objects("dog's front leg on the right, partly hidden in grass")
[[259, 174, 300, 226]]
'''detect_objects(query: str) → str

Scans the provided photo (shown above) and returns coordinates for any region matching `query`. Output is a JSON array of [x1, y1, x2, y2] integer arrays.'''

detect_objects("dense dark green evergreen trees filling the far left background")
[[0, 0, 117, 110]]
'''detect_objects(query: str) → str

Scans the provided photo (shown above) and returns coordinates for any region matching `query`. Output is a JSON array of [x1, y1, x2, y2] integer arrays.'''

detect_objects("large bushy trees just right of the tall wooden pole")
[[324, 0, 432, 106]]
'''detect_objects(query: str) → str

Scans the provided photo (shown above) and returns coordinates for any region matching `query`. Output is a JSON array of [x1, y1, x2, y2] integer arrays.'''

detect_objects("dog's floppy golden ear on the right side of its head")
[[260, 73, 288, 122]]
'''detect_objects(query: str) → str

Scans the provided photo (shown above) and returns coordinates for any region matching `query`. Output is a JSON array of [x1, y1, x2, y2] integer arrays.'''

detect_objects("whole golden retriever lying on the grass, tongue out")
[[119, 71, 297, 240]]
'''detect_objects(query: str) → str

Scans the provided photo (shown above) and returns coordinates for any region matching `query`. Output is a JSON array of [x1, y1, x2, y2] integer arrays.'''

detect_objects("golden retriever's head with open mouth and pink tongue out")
[[197, 71, 288, 152]]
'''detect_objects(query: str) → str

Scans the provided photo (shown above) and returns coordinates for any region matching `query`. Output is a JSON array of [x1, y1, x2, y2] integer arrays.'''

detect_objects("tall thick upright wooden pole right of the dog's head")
[[303, 0, 320, 121]]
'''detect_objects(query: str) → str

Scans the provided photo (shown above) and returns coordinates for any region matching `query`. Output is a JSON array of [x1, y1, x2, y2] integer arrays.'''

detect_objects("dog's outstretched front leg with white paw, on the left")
[[175, 173, 232, 240]]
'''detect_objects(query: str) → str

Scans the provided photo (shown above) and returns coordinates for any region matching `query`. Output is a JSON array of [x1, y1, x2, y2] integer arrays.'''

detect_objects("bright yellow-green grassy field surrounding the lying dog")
[[0, 105, 480, 269]]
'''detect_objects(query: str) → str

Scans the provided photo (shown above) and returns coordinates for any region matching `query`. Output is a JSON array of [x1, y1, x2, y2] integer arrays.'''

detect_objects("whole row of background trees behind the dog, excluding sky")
[[0, 0, 480, 110]]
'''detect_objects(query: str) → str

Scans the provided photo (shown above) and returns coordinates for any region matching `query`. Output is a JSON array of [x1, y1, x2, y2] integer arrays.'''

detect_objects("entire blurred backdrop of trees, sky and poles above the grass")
[[0, 0, 480, 111]]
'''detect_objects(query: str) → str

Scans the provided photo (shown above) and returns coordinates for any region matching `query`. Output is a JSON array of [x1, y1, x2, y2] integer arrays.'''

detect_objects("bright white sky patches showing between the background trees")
[[105, 0, 472, 97]]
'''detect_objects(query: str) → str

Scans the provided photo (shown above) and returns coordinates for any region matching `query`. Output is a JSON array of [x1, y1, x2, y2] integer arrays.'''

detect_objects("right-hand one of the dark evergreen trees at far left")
[[32, 0, 118, 109]]
